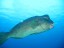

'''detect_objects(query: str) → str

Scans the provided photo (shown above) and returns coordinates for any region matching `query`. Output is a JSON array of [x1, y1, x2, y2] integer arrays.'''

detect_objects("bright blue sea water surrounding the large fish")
[[0, 0, 64, 48]]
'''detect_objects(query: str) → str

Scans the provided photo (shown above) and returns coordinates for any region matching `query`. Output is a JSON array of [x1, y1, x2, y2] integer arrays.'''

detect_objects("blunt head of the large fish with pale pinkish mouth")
[[40, 15, 54, 30]]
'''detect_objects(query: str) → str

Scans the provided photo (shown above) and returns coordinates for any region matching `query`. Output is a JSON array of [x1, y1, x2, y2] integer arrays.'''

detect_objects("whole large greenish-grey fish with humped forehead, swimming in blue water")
[[0, 15, 54, 44]]
